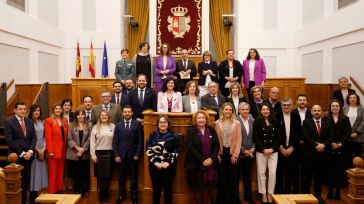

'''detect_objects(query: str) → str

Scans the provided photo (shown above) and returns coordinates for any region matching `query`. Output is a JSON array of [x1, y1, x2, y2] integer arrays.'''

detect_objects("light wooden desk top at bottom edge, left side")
[[35, 194, 81, 204]]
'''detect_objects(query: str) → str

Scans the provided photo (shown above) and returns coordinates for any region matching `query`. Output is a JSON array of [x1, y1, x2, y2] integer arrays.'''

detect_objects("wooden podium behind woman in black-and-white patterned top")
[[143, 110, 216, 204]]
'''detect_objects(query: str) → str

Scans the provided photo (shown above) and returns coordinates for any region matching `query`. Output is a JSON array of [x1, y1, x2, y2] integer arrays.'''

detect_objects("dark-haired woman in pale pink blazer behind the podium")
[[157, 78, 183, 113]]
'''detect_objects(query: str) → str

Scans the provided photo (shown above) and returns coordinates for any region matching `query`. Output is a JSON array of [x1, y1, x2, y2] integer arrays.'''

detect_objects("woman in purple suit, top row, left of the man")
[[154, 43, 176, 95]]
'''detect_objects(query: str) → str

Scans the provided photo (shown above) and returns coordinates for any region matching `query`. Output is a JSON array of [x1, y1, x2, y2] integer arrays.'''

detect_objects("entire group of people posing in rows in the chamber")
[[5, 43, 364, 204]]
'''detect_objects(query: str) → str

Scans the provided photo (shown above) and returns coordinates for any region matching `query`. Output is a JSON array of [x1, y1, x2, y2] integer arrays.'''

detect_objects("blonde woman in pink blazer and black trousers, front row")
[[215, 102, 242, 203]]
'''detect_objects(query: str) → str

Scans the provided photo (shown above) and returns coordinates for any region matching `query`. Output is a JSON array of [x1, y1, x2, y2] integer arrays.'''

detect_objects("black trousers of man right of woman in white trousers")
[[275, 151, 299, 194]]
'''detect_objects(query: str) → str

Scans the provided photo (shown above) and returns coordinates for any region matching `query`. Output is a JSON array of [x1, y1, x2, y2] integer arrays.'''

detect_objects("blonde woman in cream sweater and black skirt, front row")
[[90, 110, 115, 202]]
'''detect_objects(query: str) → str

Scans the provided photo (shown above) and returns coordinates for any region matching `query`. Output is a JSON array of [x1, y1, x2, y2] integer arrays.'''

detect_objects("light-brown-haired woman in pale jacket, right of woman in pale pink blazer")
[[182, 80, 202, 113]]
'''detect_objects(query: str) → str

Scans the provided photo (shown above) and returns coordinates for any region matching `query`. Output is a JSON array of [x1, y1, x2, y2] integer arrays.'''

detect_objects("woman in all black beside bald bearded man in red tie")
[[327, 99, 351, 200]]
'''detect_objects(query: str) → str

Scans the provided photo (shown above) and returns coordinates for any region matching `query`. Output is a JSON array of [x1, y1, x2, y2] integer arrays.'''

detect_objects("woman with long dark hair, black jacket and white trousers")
[[253, 102, 280, 203]]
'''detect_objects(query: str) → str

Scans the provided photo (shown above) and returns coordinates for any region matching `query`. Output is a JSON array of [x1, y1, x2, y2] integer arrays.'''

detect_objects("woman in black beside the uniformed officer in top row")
[[133, 42, 152, 88]]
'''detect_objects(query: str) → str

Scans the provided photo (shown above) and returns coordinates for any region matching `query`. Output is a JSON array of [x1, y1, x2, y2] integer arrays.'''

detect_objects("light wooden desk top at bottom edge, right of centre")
[[273, 194, 318, 204]]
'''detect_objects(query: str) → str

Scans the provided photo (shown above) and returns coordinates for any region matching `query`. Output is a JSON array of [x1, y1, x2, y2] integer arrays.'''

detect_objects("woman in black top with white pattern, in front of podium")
[[146, 115, 180, 204]]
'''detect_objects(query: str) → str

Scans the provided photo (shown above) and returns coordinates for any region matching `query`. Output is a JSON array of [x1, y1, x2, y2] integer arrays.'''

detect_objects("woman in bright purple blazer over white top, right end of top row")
[[242, 48, 266, 99]]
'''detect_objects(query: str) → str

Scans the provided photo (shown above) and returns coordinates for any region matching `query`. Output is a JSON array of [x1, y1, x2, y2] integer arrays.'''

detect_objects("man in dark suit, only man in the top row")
[[174, 49, 197, 93]]
